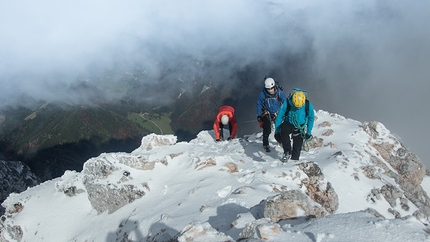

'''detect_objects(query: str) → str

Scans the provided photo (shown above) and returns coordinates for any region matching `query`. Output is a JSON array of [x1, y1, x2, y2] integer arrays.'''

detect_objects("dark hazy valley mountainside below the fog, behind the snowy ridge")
[[0, 77, 249, 181]]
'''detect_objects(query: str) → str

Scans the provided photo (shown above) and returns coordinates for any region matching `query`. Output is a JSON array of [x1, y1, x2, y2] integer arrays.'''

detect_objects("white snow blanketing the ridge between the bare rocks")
[[0, 111, 430, 242]]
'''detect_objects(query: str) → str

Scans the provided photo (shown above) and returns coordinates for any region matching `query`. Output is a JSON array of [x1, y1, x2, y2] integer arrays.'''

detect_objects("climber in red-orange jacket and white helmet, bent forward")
[[214, 105, 237, 141]]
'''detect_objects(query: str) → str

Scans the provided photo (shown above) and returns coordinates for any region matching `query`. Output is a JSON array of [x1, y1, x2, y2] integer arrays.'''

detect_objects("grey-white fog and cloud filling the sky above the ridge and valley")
[[0, 0, 430, 166]]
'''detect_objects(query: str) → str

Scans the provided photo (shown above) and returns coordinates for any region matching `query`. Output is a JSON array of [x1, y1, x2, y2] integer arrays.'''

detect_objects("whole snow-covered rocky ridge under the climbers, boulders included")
[[0, 111, 430, 241]]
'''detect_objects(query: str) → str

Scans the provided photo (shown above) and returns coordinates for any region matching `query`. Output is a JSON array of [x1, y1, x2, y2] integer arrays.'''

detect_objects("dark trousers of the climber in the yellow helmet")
[[281, 121, 303, 160]]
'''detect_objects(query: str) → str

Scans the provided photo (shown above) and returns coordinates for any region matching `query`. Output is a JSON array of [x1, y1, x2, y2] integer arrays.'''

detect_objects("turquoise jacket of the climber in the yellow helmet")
[[275, 98, 315, 134]]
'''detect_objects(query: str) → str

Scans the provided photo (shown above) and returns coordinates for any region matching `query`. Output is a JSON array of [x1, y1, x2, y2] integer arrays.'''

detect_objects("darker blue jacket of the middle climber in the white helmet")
[[257, 87, 287, 116]]
